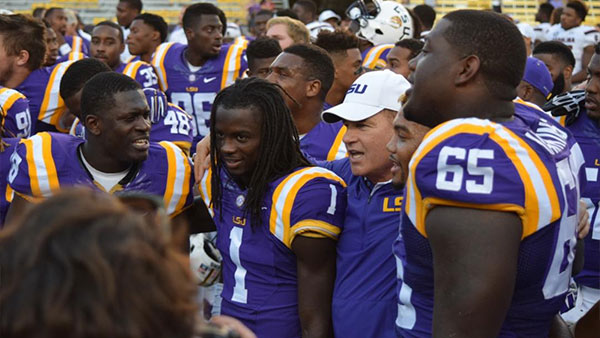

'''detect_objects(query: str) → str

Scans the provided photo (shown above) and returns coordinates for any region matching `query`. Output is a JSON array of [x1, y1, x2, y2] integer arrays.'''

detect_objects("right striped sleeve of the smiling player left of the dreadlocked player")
[[159, 141, 194, 217]]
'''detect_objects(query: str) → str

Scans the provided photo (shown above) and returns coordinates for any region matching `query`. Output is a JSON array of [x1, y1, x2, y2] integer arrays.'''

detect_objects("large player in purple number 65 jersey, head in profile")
[[394, 10, 583, 337]]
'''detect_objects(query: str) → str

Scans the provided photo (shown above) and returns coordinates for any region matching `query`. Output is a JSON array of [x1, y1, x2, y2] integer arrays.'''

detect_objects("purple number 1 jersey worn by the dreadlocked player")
[[200, 167, 346, 338]]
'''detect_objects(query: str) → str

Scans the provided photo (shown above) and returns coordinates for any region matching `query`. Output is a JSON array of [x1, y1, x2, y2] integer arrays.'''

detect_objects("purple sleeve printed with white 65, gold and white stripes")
[[405, 119, 561, 237]]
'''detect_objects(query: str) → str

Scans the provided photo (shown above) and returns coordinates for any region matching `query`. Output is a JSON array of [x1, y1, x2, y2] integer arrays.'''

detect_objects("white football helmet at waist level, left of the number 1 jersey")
[[190, 234, 221, 286]]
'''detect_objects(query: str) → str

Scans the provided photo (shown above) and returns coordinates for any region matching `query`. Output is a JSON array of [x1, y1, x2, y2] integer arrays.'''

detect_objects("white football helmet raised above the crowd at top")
[[346, 0, 414, 45]]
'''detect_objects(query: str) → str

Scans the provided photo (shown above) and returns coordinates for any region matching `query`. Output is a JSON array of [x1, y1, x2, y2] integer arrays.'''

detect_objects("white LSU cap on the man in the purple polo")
[[321, 69, 411, 123]]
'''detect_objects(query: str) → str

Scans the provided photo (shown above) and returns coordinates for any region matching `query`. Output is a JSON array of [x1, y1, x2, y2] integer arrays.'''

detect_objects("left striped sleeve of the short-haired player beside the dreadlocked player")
[[8, 133, 59, 201]]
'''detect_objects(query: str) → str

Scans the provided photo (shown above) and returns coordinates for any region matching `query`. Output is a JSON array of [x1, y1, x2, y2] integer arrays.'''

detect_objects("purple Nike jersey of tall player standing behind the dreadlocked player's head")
[[152, 42, 248, 142]]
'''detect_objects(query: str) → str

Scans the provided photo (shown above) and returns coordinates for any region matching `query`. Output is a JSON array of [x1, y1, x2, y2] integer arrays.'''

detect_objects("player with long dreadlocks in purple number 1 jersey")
[[200, 78, 346, 337]]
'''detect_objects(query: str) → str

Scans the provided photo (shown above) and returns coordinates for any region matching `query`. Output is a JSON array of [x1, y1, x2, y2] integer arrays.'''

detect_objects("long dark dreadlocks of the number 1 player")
[[210, 78, 311, 224]]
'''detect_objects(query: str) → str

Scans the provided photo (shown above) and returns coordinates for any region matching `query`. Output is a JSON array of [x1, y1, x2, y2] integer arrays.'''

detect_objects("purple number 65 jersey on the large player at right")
[[394, 115, 583, 337]]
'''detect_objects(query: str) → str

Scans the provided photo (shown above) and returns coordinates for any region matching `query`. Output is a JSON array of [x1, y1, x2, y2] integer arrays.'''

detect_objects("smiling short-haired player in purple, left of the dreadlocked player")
[[7, 72, 193, 248]]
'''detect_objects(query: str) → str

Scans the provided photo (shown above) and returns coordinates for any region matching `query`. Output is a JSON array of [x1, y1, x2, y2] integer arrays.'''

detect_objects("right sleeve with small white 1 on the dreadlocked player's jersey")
[[269, 167, 347, 248]]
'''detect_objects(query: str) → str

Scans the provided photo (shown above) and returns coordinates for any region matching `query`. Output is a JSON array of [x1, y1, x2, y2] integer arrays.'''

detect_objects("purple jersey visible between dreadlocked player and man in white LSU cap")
[[300, 121, 346, 161]]
